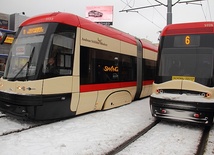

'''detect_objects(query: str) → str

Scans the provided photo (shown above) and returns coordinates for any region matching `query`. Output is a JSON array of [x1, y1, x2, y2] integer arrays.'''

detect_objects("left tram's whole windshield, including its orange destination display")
[[3, 23, 48, 81]]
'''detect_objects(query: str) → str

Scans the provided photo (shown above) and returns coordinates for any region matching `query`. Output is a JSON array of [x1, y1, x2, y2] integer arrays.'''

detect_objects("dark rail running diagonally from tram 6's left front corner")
[[106, 120, 160, 155]]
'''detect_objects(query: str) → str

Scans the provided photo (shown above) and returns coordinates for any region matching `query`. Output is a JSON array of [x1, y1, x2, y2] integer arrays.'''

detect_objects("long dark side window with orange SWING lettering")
[[80, 47, 136, 84]]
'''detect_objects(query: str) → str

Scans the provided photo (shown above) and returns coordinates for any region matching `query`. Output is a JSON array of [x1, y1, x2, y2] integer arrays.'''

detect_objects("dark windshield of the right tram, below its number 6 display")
[[159, 48, 214, 79]]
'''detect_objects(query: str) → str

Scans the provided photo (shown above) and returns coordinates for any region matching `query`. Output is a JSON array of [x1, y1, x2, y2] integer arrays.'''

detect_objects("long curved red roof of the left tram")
[[21, 12, 157, 51]]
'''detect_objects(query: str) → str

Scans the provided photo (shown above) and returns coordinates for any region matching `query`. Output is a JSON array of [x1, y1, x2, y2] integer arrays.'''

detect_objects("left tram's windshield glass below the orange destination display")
[[4, 35, 44, 80]]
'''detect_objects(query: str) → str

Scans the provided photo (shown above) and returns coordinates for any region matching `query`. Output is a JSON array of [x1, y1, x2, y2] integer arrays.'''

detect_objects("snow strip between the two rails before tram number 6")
[[118, 122, 202, 155]]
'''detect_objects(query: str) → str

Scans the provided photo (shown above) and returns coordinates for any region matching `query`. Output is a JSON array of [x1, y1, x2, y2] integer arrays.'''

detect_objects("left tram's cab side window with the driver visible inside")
[[44, 32, 74, 77]]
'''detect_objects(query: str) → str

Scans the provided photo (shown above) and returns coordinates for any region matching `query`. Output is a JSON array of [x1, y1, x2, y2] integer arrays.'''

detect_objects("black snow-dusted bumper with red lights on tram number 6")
[[150, 96, 214, 125]]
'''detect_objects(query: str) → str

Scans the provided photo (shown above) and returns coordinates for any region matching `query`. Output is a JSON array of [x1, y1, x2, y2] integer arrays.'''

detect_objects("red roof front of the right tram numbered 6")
[[161, 21, 214, 36]]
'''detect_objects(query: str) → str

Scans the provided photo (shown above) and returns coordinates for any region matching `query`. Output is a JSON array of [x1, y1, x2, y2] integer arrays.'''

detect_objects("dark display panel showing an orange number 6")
[[174, 35, 200, 47]]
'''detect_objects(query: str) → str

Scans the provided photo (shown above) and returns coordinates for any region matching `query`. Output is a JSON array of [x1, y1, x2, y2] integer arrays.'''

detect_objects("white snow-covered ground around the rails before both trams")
[[0, 98, 214, 155]]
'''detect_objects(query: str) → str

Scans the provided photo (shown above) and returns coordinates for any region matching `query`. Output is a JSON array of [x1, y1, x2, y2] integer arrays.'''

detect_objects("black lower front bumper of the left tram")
[[0, 91, 76, 120]]
